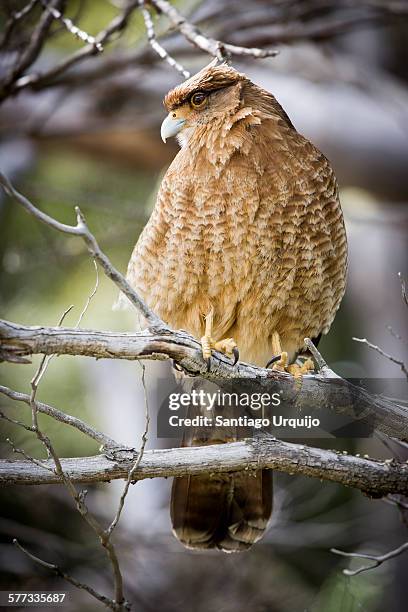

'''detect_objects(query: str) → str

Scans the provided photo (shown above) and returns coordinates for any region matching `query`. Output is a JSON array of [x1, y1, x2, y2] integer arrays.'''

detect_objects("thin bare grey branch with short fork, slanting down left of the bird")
[[0, 173, 166, 329]]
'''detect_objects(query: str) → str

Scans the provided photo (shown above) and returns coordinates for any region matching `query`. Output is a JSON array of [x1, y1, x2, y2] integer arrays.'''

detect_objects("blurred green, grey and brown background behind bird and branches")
[[0, 0, 408, 612]]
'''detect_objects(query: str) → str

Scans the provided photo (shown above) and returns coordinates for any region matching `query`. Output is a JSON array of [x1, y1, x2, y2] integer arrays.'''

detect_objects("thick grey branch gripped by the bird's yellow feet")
[[0, 320, 408, 441]]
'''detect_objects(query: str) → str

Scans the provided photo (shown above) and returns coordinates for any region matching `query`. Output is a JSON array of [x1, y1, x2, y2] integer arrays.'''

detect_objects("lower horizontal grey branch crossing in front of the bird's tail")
[[0, 436, 408, 497]]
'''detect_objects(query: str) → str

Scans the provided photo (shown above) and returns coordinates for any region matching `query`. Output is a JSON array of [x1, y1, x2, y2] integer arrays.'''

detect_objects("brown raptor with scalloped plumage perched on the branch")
[[128, 64, 347, 551]]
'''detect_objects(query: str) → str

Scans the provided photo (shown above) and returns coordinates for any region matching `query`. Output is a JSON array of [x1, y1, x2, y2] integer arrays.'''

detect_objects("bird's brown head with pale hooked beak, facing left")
[[161, 62, 248, 143]]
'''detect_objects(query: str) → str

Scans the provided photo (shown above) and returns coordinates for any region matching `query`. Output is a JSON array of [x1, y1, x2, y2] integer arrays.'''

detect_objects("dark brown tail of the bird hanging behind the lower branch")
[[171, 388, 272, 552]]
